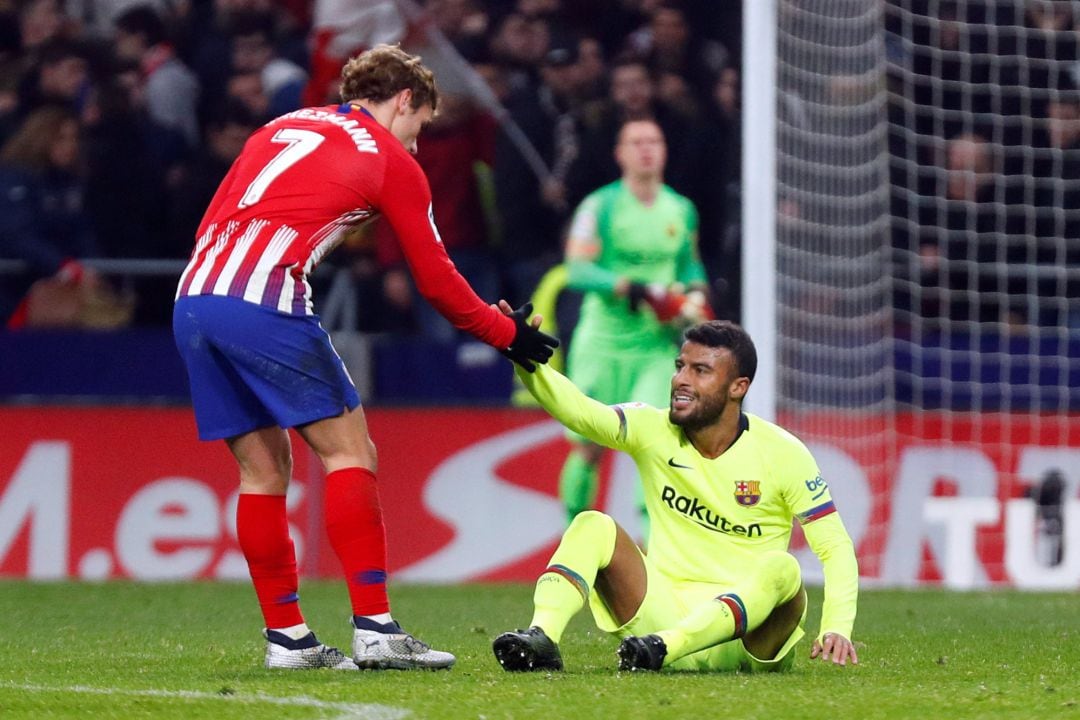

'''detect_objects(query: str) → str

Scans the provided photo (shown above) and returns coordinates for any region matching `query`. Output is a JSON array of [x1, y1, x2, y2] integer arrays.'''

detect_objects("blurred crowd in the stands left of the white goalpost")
[[0, 0, 741, 335]]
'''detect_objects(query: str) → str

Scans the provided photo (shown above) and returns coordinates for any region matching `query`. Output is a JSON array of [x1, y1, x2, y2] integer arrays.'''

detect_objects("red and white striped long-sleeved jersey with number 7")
[[176, 105, 514, 349]]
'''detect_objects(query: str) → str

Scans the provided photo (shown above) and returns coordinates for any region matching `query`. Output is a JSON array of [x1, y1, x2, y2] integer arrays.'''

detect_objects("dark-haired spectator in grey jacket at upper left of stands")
[[114, 5, 199, 148]]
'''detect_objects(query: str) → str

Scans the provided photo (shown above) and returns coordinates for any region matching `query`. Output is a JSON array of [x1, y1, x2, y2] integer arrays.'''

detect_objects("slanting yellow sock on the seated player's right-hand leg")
[[657, 551, 802, 665]]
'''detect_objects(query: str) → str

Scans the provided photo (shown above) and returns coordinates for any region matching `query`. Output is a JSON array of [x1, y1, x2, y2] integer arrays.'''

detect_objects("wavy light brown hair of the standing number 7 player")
[[341, 44, 438, 110]]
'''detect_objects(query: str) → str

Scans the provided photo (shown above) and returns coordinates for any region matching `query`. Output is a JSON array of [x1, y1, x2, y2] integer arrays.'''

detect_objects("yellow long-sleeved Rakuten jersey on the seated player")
[[517, 365, 859, 638]]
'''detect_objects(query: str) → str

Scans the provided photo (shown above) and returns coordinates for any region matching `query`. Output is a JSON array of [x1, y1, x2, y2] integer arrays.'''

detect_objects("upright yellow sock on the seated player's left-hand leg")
[[529, 511, 616, 642]]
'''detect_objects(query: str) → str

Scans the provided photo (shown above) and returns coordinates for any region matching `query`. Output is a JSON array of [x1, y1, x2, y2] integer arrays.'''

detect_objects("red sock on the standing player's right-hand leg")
[[324, 467, 390, 615]]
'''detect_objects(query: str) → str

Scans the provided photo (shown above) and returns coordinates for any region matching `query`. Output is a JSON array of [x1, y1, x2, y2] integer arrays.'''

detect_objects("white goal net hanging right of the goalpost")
[[768, 0, 1080, 587]]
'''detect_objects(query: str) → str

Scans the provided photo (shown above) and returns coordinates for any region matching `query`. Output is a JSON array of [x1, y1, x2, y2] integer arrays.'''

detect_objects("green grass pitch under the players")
[[0, 581, 1080, 720]]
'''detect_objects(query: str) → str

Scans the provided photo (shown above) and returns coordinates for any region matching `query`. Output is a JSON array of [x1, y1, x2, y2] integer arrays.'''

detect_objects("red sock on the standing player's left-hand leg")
[[237, 492, 303, 628]]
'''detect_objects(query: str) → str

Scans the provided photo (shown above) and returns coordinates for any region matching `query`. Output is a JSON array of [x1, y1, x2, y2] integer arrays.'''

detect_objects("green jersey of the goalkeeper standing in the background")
[[568, 180, 706, 352]]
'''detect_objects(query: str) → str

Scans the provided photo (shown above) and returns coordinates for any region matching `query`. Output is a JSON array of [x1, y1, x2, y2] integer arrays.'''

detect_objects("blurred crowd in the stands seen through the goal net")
[[887, 0, 1080, 331]]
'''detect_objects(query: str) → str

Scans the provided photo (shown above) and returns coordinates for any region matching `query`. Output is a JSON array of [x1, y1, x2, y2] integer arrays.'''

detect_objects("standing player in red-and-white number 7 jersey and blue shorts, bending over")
[[173, 45, 558, 669]]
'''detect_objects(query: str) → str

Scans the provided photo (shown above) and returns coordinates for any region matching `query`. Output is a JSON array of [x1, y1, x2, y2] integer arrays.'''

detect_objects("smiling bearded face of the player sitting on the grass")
[[667, 341, 750, 432]]
